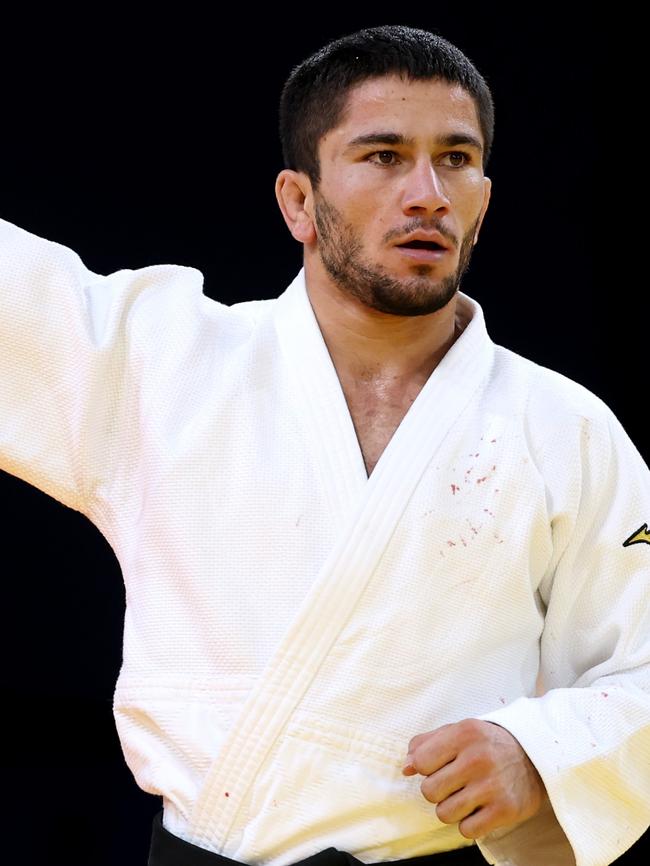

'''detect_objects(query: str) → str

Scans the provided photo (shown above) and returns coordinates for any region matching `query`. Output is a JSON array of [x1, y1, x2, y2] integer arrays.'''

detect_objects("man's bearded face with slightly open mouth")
[[306, 76, 491, 316]]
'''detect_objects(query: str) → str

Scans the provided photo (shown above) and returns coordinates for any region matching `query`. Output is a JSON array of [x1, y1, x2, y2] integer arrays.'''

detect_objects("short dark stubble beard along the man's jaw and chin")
[[314, 193, 478, 316]]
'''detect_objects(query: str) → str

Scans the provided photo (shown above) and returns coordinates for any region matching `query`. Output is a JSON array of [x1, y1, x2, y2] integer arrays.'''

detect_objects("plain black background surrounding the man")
[[0, 4, 650, 866]]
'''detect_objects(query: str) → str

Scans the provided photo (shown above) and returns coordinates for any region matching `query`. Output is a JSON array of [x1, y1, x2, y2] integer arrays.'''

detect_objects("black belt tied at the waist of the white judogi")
[[147, 809, 485, 866]]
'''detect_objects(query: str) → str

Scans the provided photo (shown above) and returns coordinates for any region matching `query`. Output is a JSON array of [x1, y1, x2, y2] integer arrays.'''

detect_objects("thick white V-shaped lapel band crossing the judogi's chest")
[[189, 270, 494, 850]]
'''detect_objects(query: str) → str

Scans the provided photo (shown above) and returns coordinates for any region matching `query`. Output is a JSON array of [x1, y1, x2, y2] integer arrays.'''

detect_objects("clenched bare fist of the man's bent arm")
[[402, 719, 548, 839]]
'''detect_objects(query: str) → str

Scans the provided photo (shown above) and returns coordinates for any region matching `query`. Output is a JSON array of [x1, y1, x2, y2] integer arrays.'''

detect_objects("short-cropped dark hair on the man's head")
[[279, 24, 494, 189]]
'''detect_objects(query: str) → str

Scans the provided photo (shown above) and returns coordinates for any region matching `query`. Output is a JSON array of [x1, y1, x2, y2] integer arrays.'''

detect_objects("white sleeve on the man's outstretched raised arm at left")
[[0, 220, 202, 514]]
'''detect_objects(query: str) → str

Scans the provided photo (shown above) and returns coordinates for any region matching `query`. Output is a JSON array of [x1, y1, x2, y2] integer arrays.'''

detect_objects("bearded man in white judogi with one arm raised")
[[0, 27, 650, 866]]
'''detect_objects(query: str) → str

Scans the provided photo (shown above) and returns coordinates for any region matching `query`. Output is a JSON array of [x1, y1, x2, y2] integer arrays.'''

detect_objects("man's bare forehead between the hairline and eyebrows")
[[320, 75, 483, 158]]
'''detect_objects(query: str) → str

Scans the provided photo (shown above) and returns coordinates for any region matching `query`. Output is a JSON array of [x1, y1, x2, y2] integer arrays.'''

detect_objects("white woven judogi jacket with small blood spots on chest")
[[0, 214, 650, 866]]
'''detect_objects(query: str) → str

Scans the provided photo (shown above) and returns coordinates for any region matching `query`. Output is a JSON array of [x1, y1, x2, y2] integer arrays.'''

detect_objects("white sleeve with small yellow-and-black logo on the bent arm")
[[470, 401, 650, 866]]
